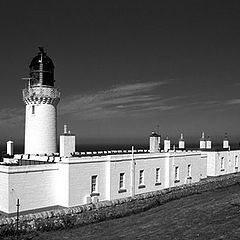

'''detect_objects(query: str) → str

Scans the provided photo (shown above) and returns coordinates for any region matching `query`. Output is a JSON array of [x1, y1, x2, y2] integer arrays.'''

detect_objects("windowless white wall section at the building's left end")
[[0, 164, 58, 213]]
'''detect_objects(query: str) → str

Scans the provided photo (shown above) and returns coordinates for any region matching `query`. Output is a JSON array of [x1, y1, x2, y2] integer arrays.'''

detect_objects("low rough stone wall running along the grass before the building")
[[0, 173, 240, 236]]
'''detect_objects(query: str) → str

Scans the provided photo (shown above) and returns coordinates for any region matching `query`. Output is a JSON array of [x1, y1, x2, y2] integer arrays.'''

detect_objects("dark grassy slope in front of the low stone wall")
[[4, 185, 240, 240]]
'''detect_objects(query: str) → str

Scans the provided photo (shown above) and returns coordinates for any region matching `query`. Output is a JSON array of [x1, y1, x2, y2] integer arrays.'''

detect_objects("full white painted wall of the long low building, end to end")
[[0, 150, 240, 213]]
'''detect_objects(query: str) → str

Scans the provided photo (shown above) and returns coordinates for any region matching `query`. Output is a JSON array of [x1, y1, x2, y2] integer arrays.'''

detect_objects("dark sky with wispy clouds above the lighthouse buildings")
[[0, 0, 240, 147]]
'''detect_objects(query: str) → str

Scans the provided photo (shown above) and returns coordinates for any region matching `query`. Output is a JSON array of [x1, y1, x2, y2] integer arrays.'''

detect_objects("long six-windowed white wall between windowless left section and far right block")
[[63, 152, 204, 206]]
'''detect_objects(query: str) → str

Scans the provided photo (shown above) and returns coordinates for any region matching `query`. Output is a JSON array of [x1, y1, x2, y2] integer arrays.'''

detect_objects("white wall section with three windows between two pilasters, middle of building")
[[107, 153, 166, 199]]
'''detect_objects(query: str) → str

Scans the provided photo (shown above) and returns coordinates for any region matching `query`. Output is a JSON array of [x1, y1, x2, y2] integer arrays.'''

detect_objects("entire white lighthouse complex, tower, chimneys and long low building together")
[[0, 49, 240, 214]]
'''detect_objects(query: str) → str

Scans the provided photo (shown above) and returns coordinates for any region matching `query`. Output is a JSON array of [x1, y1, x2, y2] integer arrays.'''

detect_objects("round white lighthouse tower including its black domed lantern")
[[23, 48, 60, 154]]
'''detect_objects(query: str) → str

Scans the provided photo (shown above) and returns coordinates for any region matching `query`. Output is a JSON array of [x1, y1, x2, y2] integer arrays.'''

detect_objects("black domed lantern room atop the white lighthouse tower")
[[29, 47, 54, 87]]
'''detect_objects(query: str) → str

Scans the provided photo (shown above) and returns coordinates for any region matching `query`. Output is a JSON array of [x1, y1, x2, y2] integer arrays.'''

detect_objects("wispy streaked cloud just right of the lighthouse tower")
[[59, 81, 176, 120]]
